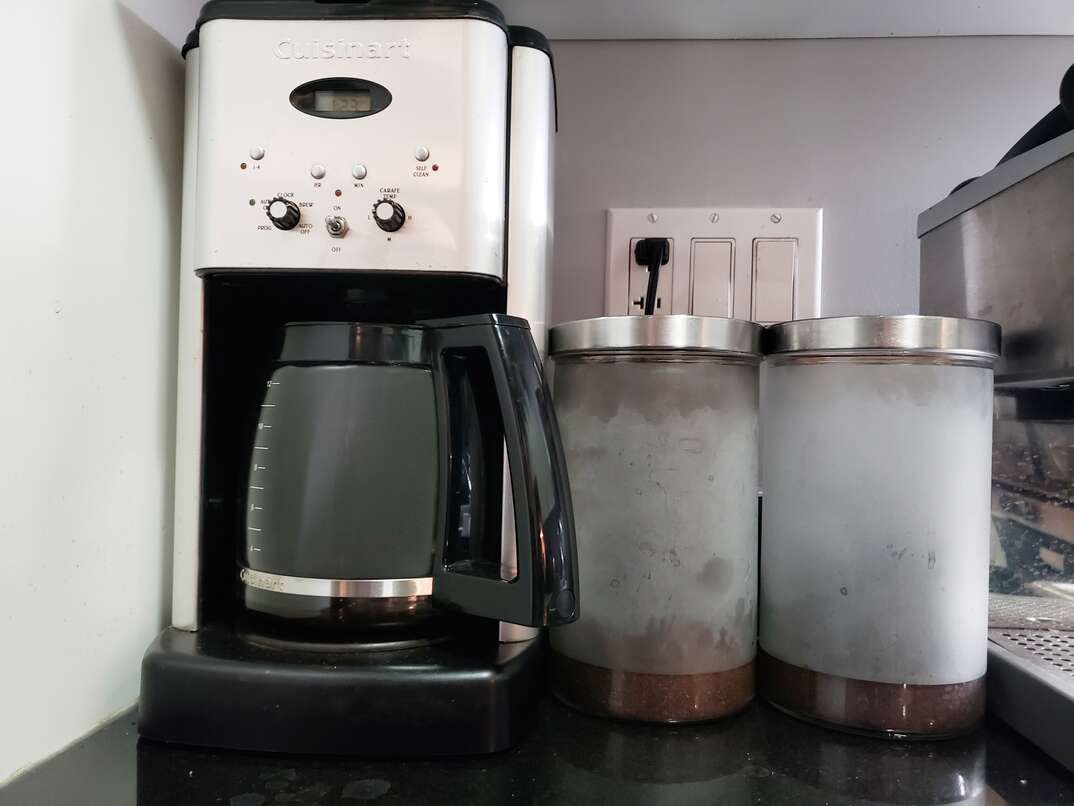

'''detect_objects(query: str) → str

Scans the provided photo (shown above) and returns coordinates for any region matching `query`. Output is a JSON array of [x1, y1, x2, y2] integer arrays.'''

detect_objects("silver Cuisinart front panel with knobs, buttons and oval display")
[[188, 19, 508, 277]]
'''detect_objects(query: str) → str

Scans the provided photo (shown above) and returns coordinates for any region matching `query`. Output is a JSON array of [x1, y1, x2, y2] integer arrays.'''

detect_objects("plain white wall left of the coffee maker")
[[0, 0, 195, 781]]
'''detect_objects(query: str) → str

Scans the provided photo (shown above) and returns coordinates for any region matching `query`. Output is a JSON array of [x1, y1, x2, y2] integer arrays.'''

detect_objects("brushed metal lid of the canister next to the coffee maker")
[[549, 314, 763, 358]]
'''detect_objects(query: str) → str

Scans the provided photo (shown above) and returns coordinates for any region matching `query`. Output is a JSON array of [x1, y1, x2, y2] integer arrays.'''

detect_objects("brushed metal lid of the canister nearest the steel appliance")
[[764, 315, 1000, 360]]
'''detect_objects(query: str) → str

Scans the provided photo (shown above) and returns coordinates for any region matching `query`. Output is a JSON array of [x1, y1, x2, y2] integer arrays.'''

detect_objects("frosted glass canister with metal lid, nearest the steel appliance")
[[758, 316, 1000, 737]]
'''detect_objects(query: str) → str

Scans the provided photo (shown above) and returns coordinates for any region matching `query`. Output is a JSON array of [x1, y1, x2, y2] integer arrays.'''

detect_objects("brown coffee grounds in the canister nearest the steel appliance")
[[757, 649, 985, 738]]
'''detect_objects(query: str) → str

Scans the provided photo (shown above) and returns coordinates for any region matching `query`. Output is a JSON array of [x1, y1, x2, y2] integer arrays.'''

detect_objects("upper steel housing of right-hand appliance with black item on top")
[[917, 52, 1074, 388]]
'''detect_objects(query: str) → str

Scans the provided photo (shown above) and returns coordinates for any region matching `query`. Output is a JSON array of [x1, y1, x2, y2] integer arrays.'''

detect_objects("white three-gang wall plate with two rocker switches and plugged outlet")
[[605, 207, 823, 323]]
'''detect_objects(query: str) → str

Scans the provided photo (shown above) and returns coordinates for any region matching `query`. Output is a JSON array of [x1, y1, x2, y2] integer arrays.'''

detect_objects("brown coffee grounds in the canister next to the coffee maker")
[[552, 652, 754, 722]]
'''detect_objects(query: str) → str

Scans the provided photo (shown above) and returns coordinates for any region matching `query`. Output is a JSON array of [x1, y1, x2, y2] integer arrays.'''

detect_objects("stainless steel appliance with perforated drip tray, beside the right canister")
[[918, 74, 1074, 769]]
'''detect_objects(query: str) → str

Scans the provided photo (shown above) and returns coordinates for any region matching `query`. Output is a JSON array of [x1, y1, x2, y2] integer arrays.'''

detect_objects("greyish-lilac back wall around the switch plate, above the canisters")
[[551, 37, 1074, 321]]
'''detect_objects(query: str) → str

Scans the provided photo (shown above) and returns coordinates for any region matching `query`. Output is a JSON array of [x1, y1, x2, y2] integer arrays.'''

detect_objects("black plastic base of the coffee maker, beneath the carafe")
[[139, 627, 543, 758]]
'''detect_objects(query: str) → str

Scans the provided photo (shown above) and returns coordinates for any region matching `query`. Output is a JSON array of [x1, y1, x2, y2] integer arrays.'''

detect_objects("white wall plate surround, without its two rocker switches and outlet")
[[605, 207, 823, 319]]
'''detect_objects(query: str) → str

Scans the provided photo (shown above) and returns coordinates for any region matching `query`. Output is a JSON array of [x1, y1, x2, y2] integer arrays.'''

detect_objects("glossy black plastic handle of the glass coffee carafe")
[[422, 314, 578, 627]]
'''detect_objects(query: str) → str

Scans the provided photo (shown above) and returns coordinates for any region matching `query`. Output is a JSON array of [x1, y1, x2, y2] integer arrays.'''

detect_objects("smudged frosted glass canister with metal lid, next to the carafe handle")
[[550, 316, 761, 722]]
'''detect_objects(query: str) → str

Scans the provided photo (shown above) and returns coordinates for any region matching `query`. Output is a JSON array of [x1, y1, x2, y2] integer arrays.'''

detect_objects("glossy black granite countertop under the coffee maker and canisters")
[[0, 700, 1074, 806]]
